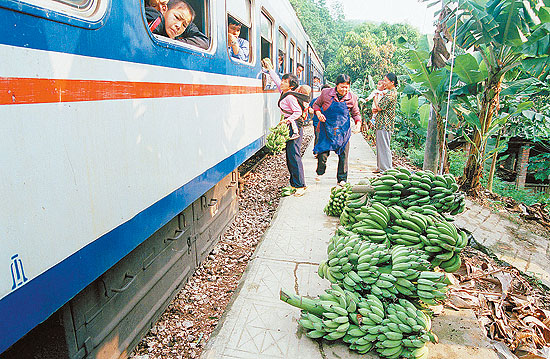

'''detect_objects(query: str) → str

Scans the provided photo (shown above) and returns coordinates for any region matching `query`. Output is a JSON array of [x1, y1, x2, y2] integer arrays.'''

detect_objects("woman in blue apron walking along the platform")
[[313, 74, 361, 185]]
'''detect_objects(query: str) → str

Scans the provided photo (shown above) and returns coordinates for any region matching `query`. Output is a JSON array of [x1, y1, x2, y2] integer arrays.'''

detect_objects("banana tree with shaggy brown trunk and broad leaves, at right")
[[430, 0, 550, 191]]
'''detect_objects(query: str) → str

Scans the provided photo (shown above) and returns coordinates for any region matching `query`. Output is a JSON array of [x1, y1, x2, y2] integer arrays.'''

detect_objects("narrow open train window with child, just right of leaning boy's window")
[[226, 0, 252, 62]]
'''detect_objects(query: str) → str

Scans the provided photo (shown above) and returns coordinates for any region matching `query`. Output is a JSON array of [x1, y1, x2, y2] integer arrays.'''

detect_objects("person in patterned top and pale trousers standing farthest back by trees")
[[372, 72, 397, 173]]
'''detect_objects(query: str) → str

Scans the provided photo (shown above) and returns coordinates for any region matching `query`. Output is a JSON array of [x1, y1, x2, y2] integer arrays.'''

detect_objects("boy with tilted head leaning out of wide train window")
[[145, 0, 210, 49]]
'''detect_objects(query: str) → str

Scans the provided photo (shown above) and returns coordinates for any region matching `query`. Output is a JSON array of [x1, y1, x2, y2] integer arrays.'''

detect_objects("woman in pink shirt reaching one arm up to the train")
[[262, 58, 309, 197]]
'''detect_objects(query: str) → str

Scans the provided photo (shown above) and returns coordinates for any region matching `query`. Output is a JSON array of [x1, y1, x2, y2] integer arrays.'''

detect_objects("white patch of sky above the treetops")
[[327, 0, 438, 34]]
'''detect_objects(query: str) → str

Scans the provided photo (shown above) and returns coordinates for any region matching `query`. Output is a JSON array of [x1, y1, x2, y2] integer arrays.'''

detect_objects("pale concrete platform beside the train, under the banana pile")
[[201, 134, 497, 359]]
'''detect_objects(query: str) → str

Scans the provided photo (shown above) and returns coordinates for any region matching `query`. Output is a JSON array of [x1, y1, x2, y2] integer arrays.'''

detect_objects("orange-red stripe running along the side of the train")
[[0, 77, 264, 105]]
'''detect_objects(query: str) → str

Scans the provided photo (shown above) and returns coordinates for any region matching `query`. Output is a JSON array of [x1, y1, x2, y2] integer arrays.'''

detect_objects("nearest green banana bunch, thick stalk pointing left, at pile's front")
[[280, 284, 437, 359]]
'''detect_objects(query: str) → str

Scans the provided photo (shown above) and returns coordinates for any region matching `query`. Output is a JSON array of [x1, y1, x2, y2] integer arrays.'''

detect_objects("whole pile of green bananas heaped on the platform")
[[281, 168, 474, 359]]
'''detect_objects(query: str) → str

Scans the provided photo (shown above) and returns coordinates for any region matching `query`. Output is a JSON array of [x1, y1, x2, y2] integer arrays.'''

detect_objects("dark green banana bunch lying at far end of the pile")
[[372, 167, 465, 215]]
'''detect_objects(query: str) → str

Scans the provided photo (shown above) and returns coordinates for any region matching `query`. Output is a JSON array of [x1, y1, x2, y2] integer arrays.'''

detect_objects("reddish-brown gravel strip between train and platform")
[[130, 127, 313, 359]]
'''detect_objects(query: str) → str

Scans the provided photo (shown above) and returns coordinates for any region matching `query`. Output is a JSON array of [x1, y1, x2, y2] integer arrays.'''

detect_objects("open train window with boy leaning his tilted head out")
[[145, 0, 210, 49]]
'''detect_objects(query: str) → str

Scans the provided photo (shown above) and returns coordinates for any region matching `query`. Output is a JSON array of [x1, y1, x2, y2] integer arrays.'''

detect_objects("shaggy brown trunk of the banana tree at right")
[[460, 72, 502, 194]]
